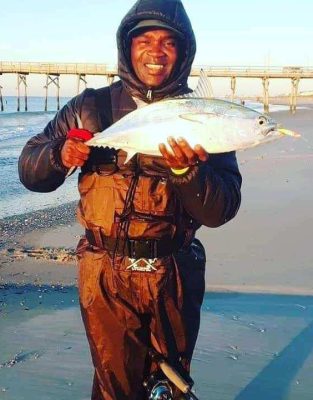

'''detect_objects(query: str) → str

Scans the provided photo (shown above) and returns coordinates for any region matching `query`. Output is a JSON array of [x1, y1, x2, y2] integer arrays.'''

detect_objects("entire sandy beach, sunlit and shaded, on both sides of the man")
[[0, 108, 313, 400]]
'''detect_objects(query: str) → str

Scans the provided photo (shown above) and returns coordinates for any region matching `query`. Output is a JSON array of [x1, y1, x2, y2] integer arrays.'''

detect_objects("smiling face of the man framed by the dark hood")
[[131, 29, 178, 88]]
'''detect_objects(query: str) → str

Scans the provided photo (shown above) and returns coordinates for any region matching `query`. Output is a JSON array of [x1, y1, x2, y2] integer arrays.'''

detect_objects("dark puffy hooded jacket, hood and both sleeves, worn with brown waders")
[[19, 0, 241, 228]]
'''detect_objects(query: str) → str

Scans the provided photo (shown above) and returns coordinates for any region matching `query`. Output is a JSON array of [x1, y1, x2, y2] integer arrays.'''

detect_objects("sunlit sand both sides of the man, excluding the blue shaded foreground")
[[0, 109, 313, 295]]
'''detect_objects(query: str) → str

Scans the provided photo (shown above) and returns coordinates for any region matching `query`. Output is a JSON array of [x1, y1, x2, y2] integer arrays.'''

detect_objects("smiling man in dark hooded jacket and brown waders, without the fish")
[[19, 0, 241, 400]]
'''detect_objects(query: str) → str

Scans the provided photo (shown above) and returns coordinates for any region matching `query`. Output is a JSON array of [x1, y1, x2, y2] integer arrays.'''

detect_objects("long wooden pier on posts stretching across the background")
[[0, 61, 313, 113]]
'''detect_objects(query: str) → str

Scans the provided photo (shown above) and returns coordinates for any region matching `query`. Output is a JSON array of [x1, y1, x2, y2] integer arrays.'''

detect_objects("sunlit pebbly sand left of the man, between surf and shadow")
[[0, 203, 82, 285]]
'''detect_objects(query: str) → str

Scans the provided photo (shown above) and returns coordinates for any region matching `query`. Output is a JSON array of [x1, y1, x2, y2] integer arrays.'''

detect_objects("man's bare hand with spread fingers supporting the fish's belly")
[[159, 137, 209, 169]]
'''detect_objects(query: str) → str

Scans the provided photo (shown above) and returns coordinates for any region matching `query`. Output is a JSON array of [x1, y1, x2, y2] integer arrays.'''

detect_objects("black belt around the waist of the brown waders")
[[86, 229, 183, 260]]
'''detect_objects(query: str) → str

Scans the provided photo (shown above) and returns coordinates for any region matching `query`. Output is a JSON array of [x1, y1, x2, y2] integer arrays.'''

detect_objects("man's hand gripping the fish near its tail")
[[61, 139, 90, 168]]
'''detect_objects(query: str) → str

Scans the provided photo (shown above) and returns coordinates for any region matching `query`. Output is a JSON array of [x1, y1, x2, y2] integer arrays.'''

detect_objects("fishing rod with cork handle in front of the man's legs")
[[149, 349, 200, 400]]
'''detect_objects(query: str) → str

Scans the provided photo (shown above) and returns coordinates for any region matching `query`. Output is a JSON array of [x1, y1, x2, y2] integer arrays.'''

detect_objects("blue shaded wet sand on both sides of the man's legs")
[[0, 285, 313, 400]]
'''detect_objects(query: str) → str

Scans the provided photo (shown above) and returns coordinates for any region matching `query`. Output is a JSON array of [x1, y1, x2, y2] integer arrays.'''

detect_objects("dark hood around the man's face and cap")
[[117, 0, 196, 101]]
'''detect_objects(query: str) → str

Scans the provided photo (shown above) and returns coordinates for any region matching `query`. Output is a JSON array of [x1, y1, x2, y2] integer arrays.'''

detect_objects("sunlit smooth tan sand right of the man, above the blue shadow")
[[199, 109, 313, 295]]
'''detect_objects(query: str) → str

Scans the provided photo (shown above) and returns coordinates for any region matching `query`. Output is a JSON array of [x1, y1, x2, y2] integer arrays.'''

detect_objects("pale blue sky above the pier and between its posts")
[[0, 0, 313, 96]]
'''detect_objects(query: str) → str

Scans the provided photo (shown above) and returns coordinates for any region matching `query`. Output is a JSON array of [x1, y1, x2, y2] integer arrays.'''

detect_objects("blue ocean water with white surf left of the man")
[[0, 97, 78, 219]]
